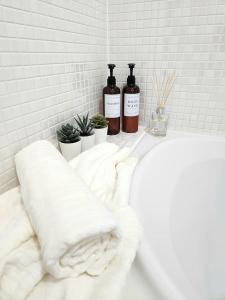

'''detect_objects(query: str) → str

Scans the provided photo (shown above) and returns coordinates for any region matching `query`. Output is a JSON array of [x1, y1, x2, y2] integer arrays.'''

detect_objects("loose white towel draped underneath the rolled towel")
[[0, 143, 140, 300]]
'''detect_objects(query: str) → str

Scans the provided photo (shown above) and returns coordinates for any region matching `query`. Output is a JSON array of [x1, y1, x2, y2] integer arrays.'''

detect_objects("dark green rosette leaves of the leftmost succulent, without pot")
[[56, 123, 80, 144]]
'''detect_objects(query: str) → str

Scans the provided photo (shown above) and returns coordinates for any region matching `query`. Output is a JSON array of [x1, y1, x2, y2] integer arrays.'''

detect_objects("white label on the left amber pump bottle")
[[105, 94, 120, 118]]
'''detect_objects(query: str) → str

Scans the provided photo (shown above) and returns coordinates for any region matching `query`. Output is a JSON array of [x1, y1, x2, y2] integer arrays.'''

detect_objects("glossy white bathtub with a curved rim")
[[123, 137, 225, 300]]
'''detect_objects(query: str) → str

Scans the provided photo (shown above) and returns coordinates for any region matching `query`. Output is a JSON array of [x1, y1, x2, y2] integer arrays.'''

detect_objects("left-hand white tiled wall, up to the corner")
[[0, 0, 107, 193]]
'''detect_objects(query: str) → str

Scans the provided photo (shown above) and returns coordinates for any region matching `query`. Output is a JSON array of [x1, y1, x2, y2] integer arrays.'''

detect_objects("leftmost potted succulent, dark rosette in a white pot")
[[57, 123, 81, 160]]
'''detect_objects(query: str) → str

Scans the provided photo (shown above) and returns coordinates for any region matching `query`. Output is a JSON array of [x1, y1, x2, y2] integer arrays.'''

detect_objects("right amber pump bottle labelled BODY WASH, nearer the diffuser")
[[122, 64, 140, 133]]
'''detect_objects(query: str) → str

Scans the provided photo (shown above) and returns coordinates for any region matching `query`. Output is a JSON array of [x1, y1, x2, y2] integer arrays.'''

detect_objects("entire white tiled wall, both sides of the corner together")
[[0, 0, 225, 193]]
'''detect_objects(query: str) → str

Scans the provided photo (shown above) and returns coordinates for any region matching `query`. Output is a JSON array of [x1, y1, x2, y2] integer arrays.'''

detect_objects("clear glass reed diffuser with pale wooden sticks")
[[150, 71, 176, 136]]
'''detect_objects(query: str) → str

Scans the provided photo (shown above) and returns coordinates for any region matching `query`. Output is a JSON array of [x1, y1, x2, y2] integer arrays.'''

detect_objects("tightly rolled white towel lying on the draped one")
[[16, 141, 120, 278]]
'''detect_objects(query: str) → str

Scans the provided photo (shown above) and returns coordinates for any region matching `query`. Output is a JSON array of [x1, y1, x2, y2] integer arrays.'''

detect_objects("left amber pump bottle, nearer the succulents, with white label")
[[103, 64, 120, 135]]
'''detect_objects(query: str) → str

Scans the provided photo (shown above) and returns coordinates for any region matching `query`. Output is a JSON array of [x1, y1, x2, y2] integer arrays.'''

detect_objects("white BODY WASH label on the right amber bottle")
[[124, 93, 140, 117]]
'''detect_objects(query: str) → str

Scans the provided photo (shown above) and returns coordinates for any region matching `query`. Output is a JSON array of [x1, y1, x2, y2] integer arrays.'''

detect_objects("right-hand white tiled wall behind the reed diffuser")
[[109, 0, 225, 136]]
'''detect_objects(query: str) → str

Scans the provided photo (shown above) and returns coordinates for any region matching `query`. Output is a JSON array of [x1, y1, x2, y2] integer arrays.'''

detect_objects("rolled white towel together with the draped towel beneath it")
[[0, 141, 141, 300]]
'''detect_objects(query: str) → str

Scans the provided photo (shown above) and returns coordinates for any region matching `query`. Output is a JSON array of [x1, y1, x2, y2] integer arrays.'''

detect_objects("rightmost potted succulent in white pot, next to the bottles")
[[91, 114, 108, 144]]
